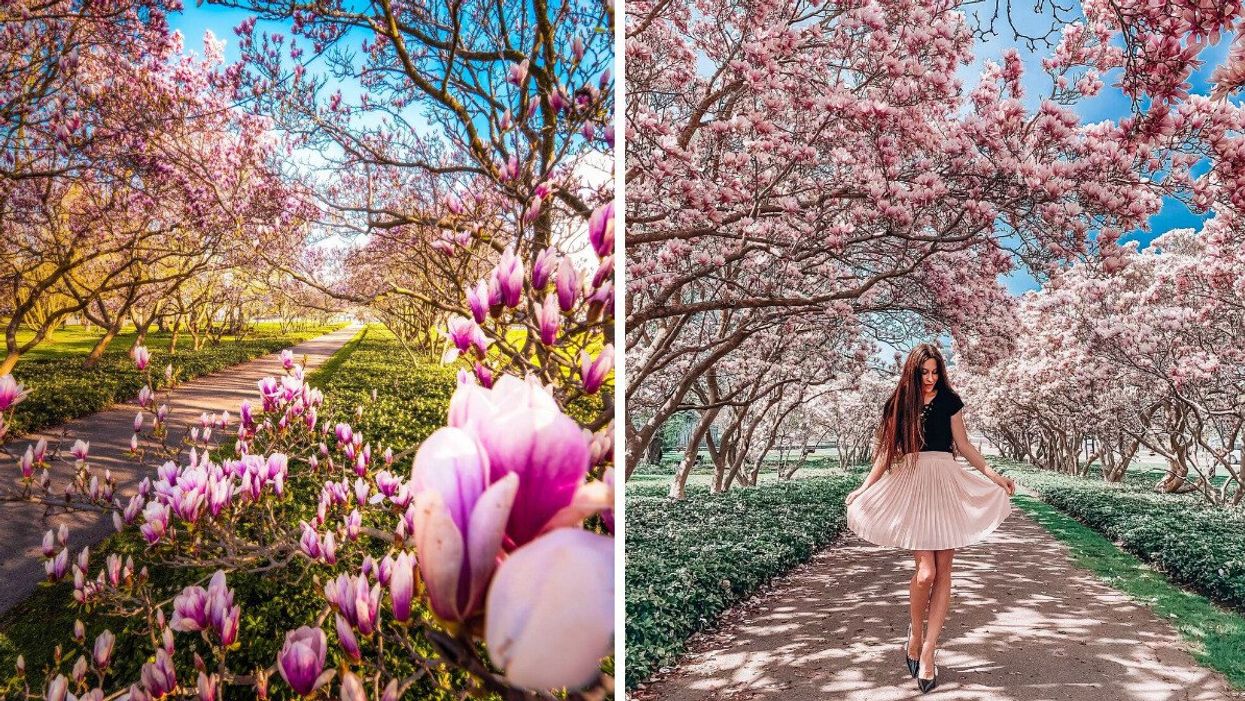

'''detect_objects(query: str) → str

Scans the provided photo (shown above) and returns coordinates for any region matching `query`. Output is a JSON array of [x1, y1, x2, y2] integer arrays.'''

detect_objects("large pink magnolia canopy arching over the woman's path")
[[626, 0, 1243, 478]]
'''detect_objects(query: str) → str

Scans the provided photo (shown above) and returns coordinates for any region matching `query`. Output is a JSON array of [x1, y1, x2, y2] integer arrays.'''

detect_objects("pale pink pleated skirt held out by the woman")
[[848, 451, 1011, 550]]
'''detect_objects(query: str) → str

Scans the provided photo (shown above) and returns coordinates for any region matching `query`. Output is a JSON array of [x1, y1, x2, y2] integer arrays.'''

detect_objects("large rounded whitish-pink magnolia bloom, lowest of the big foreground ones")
[[484, 528, 614, 690]]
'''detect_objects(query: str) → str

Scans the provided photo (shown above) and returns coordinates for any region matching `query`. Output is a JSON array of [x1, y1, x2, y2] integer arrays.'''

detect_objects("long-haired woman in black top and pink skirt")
[[847, 344, 1016, 692]]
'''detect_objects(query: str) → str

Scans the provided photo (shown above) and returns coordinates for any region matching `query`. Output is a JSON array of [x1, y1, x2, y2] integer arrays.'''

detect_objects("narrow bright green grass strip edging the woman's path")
[[1013, 496, 1245, 690]]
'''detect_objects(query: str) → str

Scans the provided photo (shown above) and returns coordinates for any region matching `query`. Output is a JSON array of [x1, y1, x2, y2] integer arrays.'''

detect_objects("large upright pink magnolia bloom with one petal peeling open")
[[408, 427, 518, 620]]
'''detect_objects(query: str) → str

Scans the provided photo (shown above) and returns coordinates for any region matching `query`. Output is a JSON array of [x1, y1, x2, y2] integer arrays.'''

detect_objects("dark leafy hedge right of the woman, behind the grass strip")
[[997, 461, 1245, 611]]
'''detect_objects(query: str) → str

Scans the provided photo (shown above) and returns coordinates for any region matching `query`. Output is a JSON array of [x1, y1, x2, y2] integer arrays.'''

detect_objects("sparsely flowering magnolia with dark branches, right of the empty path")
[[214, 0, 614, 408]]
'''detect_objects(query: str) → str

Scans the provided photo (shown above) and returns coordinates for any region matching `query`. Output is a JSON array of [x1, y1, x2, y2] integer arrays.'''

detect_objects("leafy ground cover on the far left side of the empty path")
[[10, 324, 342, 433]]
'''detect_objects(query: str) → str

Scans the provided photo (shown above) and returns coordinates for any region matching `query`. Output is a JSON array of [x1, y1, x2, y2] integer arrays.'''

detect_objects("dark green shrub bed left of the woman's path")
[[625, 474, 860, 689]]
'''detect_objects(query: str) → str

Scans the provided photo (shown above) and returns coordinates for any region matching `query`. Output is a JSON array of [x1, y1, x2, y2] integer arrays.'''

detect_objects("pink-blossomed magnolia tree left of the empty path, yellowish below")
[[0, 2, 305, 372]]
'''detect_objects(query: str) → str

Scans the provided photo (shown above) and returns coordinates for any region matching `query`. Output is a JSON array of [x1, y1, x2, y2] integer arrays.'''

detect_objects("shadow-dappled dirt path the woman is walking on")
[[632, 509, 1243, 701]]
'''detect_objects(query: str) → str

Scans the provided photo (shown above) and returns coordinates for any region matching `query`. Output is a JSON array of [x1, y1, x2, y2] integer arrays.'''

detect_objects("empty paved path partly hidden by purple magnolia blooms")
[[0, 325, 359, 613]]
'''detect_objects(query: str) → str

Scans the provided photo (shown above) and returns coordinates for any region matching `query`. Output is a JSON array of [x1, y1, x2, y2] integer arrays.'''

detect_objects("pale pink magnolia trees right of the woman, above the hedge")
[[971, 229, 1245, 503]]
